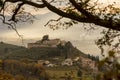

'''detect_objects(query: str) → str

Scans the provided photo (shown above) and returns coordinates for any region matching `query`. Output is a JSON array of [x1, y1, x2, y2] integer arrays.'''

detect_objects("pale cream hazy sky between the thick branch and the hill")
[[0, 0, 117, 55]]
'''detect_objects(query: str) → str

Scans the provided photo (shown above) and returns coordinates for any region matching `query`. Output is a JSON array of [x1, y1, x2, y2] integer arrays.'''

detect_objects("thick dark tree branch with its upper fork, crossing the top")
[[2, 0, 120, 31]]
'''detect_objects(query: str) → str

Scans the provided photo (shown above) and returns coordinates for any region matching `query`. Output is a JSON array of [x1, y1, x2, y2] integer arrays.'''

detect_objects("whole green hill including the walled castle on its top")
[[0, 35, 96, 61]]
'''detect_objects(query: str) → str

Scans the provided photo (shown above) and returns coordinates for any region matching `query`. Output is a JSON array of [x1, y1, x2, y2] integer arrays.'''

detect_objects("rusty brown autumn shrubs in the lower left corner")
[[0, 60, 49, 80]]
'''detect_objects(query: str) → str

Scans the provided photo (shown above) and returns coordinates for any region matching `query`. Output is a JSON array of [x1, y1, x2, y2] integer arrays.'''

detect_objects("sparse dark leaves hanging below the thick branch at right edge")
[[96, 29, 120, 56]]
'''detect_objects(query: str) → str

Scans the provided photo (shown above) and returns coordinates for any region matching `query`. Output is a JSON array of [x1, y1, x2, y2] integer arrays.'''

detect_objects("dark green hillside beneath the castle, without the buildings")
[[0, 42, 87, 60]]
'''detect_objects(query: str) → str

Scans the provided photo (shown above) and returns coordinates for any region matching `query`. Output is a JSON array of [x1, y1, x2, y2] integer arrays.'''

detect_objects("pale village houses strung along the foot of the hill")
[[38, 57, 98, 71]]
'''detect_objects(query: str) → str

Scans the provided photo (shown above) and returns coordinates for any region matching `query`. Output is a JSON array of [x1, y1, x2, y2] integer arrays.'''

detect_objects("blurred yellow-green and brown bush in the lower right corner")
[[98, 50, 120, 80]]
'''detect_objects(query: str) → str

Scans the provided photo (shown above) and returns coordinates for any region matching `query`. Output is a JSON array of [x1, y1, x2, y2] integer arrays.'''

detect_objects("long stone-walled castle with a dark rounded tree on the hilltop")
[[28, 35, 66, 48]]
